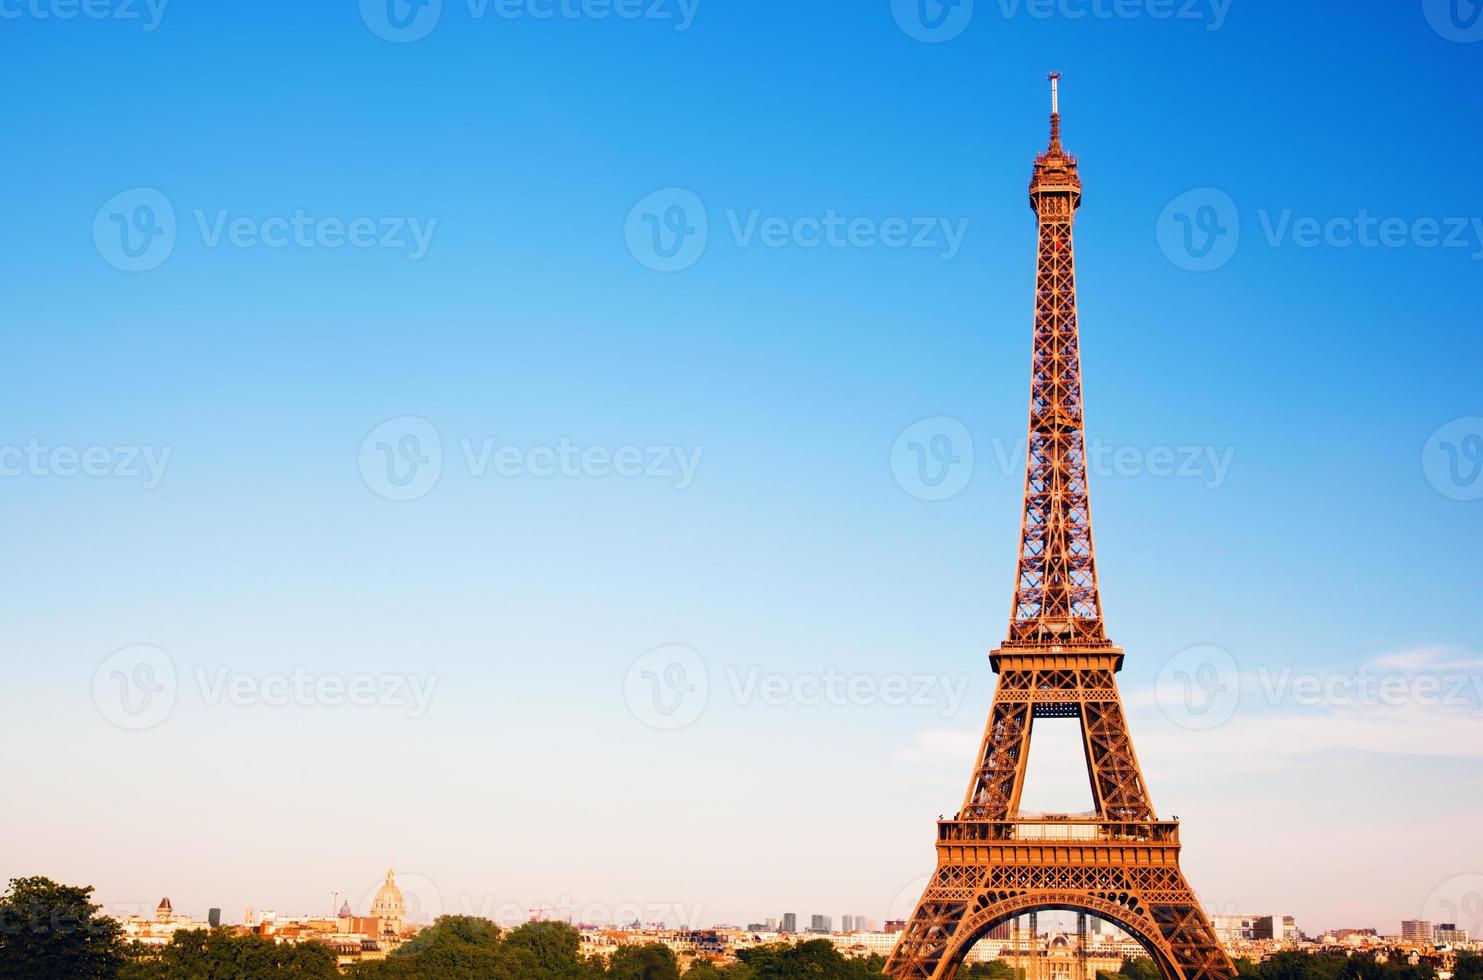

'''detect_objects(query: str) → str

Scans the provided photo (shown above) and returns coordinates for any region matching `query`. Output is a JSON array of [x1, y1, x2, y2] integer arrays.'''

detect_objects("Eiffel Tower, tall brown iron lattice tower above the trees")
[[885, 74, 1235, 980]]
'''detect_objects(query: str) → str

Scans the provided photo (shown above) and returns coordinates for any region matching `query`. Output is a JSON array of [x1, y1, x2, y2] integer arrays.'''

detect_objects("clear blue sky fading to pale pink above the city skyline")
[[0, 0, 1483, 930]]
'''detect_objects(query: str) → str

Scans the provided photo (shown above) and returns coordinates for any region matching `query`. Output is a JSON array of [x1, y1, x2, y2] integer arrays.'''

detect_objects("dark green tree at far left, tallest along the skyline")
[[0, 878, 123, 980]]
